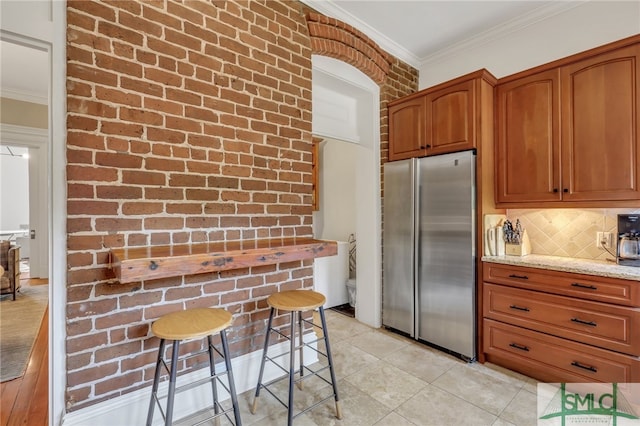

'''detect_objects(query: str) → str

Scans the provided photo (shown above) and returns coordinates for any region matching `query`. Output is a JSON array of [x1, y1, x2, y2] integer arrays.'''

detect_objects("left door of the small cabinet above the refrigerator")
[[389, 96, 427, 161]]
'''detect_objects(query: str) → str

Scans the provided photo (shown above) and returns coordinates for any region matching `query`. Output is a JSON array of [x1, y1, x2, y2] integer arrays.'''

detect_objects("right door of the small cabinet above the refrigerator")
[[427, 79, 476, 155]]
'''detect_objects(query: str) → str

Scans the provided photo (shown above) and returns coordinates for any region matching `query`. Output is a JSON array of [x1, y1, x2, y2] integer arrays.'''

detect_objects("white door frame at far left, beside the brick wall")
[[0, 1, 67, 425]]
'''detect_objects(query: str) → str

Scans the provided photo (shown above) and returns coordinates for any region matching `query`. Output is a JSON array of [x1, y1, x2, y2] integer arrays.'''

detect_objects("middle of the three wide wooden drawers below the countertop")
[[483, 283, 640, 355]]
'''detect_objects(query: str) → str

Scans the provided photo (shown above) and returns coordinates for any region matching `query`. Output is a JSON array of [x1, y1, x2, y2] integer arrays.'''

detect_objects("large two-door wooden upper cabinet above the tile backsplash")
[[496, 37, 640, 207]]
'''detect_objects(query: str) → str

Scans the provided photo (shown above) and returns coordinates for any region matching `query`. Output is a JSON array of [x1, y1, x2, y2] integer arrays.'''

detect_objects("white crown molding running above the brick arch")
[[300, 0, 421, 68]]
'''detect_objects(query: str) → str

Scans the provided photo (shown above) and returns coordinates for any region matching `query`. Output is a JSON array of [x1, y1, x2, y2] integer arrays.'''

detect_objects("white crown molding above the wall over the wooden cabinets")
[[419, 0, 589, 69]]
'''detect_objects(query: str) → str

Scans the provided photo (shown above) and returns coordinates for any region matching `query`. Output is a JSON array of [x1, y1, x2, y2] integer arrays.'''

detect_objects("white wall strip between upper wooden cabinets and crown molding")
[[419, 1, 640, 89]]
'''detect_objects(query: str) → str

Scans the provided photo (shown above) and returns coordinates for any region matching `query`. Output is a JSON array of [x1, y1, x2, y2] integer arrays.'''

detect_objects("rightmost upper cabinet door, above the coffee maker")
[[561, 44, 640, 201]]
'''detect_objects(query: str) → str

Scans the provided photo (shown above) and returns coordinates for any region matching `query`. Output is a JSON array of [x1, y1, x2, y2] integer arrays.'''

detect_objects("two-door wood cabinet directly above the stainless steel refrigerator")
[[389, 70, 496, 161]]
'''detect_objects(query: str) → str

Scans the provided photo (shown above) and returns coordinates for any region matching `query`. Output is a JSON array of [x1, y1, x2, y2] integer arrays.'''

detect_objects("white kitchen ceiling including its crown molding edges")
[[302, 0, 584, 68]]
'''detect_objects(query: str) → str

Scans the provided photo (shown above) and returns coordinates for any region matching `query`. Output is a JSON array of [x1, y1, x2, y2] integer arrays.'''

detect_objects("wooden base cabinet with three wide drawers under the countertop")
[[482, 262, 640, 383]]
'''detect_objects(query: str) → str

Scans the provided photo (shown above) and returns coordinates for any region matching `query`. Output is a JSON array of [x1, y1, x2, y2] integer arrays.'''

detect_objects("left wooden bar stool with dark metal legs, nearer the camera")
[[147, 308, 241, 426]]
